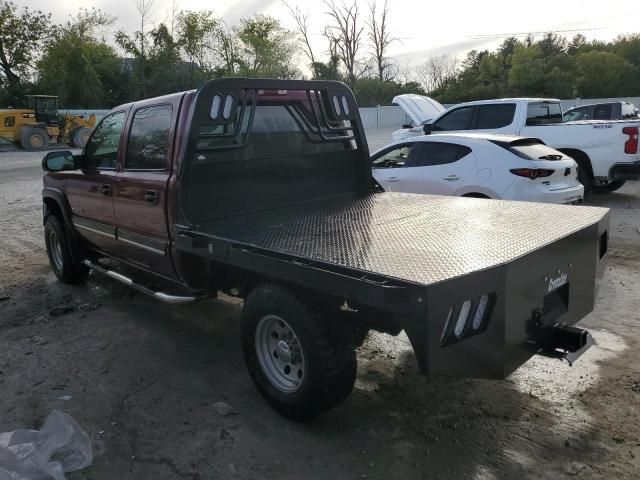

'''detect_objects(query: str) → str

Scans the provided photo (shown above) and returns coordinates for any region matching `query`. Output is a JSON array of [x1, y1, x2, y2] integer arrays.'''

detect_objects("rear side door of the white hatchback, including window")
[[402, 142, 476, 195]]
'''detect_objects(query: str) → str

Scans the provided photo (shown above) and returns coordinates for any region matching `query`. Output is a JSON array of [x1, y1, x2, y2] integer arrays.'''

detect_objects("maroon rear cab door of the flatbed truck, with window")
[[114, 103, 179, 277]]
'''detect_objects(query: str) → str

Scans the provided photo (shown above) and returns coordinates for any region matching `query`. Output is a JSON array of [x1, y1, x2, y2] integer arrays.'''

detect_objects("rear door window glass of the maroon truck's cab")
[[125, 105, 171, 170]]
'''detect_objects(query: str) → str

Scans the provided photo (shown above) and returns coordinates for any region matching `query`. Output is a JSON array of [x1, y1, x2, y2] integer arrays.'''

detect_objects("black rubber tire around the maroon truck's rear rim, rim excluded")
[[242, 284, 357, 422]]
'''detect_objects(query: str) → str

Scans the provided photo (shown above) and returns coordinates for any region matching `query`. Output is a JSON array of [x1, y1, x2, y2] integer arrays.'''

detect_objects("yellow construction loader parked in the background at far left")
[[0, 95, 96, 151]]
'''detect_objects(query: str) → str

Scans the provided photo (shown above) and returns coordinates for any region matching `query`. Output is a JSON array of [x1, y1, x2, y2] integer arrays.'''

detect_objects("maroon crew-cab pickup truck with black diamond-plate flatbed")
[[43, 79, 608, 420]]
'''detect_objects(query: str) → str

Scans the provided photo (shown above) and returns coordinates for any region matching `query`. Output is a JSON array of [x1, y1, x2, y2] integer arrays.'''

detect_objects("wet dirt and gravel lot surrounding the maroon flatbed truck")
[[0, 132, 640, 480]]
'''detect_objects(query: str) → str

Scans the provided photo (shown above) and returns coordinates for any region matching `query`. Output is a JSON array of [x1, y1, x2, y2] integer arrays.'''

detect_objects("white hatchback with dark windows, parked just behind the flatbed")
[[371, 133, 584, 204]]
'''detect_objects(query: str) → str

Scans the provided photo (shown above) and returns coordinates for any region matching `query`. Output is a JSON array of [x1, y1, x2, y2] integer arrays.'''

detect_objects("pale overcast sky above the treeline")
[[16, 0, 640, 68]]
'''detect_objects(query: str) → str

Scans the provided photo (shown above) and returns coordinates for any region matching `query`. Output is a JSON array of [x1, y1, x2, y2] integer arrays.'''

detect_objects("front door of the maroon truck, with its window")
[[66, 111, 126, 252]]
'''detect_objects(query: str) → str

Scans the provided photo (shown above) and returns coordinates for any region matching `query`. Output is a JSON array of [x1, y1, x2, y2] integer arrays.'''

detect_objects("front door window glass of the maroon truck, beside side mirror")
[[84, 112, 124, 170]]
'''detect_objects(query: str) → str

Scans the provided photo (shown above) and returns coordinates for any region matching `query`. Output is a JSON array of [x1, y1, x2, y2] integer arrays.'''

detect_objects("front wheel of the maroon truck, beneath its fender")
[[44, 215, 89, 284]]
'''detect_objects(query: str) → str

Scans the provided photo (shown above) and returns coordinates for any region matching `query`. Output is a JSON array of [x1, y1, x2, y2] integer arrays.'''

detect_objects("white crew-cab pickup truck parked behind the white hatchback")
[[393, 97, 640, 193]]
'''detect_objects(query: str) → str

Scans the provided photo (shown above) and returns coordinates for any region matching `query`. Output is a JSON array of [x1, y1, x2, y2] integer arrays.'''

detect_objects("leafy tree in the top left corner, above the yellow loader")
[[0, 1, 51, 104]]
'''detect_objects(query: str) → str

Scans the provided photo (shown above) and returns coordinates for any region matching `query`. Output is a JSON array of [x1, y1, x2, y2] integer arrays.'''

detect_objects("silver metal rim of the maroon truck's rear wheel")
[[255, 315, 306, 393]]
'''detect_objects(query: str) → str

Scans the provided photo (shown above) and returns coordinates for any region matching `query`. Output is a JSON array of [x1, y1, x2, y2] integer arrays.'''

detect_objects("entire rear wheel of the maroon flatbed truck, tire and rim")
[[242, 284, 357, 421]]
